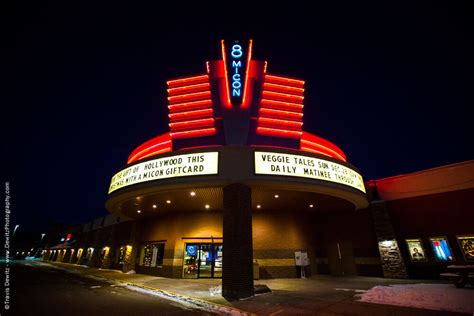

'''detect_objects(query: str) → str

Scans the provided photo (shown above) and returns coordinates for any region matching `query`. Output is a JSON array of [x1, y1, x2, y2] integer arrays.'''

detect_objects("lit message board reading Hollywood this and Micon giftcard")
[[109, 152, 219, 194]]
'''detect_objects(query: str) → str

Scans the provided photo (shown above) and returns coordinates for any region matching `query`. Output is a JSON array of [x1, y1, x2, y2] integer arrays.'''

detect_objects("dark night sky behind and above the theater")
[[2, 1, 474, 230]]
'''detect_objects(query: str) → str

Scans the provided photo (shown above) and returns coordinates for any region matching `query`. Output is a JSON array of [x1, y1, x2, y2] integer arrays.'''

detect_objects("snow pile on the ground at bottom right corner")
[[356, 283, 474, 314]]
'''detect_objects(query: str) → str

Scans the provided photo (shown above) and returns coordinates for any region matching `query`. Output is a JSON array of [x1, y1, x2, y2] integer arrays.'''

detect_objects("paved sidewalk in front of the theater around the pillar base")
[[38, 262, 463, 316]]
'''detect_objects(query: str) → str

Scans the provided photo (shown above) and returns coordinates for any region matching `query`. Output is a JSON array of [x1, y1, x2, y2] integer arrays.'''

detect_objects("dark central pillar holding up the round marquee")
[[222, 183, 254, 299]]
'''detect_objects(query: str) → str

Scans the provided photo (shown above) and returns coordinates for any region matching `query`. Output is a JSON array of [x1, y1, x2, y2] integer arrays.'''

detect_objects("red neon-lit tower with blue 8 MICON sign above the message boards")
[[127, 40, 346, 164]]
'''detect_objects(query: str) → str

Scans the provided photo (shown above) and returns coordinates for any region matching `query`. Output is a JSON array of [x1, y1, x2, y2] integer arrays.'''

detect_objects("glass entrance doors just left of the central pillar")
[[183, 243, 222, 279]]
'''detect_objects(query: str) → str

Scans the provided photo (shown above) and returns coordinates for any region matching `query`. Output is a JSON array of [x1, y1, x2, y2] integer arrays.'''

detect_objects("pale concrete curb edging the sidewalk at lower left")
[[36, 261, 256, 316]]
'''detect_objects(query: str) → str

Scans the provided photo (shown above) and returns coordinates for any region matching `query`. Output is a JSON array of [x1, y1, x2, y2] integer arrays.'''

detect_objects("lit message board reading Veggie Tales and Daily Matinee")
[[255, 151, 365, 193]]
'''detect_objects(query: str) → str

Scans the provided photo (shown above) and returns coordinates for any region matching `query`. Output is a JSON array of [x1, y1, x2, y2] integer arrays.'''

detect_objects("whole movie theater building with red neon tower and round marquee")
[[44, 41, 474, 297]]
